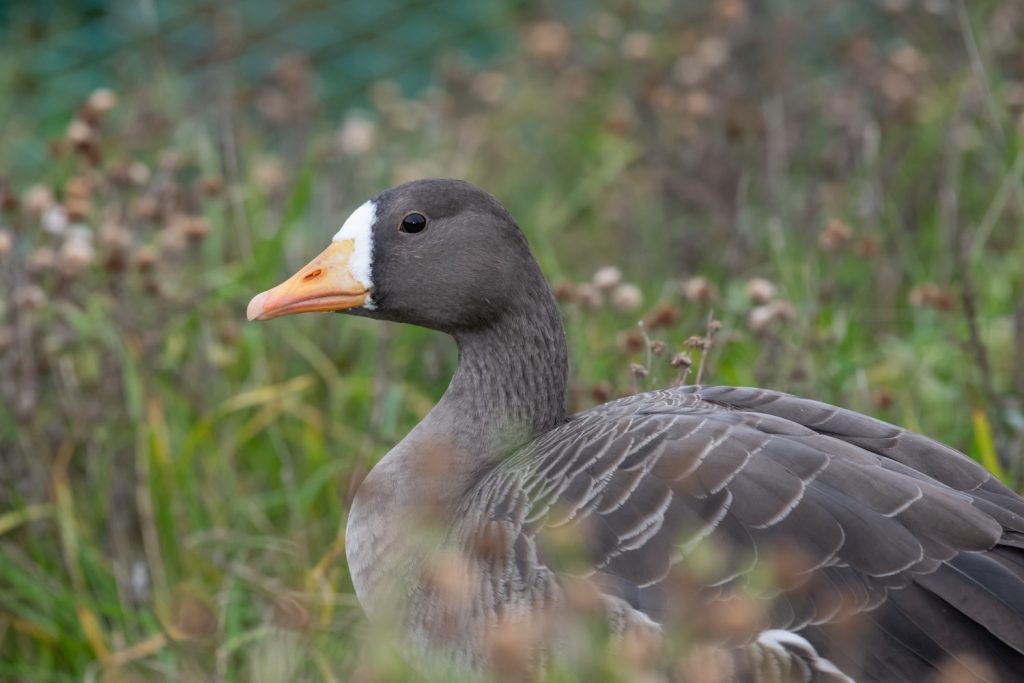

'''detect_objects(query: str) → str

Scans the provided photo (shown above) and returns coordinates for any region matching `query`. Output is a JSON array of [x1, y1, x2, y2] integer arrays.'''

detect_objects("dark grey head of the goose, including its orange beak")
[[247, 179, 547, 334]]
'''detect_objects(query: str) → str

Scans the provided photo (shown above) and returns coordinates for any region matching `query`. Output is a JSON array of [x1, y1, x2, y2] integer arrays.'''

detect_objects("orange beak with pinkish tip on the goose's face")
[[246, 240, 370, 321]]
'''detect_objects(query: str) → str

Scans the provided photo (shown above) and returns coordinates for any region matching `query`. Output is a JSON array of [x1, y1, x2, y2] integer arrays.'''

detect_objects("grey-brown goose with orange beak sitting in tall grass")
[[247, 179, 1024, 683]]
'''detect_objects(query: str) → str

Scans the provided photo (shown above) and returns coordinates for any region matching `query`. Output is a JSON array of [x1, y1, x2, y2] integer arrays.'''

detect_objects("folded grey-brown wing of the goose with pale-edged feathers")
[[466, 387, 1024, 680]]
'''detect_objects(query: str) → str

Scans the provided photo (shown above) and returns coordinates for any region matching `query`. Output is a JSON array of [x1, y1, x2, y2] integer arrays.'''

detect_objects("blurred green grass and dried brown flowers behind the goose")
[[0, 0, 1024, 682]]
